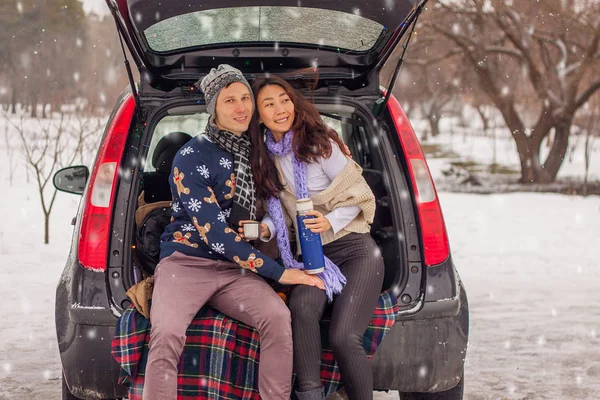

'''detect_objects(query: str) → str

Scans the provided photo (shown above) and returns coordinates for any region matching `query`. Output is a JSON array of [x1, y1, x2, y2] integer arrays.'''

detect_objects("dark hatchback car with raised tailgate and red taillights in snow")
[[54, 0, 469, 400]]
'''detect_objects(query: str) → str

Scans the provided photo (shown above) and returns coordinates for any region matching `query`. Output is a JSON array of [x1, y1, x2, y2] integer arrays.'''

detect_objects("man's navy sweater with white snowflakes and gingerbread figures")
[[160, 135, 285, 281]]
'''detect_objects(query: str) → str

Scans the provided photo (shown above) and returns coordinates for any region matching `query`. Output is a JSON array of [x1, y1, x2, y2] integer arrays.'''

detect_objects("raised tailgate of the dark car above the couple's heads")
[[106, 0, 417, 95]]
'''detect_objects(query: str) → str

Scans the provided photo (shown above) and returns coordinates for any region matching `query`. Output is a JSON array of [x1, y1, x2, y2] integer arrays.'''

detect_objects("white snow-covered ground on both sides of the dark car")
[[0, 115, 600, 400]]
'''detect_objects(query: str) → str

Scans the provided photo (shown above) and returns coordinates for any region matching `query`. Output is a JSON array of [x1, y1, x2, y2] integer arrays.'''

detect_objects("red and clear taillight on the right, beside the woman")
[[388, 95, 450, 265]]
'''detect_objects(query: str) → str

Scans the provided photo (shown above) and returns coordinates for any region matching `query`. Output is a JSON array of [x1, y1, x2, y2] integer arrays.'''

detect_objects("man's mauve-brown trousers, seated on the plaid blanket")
[[143, 252, 293, 400]]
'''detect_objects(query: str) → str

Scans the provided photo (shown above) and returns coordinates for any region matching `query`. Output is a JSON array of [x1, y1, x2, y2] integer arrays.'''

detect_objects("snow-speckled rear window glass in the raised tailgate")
[[144, 7, 384, 52]]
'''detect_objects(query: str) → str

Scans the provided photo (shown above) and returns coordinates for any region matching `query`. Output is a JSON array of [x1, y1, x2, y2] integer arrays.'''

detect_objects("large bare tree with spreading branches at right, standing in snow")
[[414, 0, 600, 183]]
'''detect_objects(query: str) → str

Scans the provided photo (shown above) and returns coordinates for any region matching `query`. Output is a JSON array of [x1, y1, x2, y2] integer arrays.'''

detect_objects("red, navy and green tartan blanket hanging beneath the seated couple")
[[112, 291, 398, 400]]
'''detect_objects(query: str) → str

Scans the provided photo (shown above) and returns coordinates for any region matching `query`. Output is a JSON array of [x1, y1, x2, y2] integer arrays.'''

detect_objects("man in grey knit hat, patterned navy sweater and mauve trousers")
[[143, 65, 324, 400]]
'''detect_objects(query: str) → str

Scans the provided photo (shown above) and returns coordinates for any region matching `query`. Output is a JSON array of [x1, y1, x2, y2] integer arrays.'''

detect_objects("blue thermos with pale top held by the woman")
[[296, 199, 325, 274]]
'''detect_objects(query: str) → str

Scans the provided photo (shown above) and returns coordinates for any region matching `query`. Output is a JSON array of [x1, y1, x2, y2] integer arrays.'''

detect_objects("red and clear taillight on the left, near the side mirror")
[[79, 95, 135, 272]]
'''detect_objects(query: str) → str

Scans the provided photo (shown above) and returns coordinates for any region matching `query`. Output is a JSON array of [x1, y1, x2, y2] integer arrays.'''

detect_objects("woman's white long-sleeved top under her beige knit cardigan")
[[262, 140, 360, 241]]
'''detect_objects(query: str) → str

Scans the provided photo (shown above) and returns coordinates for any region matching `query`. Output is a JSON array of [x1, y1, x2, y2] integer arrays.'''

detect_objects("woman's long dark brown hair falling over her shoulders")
[[249, 76, 344, 199]]
